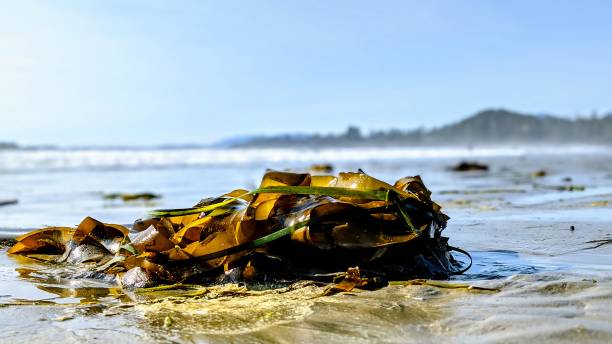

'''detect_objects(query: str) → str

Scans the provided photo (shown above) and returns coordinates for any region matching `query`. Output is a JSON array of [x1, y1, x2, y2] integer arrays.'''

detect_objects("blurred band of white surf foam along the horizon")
[[0, 147, 611, 172]]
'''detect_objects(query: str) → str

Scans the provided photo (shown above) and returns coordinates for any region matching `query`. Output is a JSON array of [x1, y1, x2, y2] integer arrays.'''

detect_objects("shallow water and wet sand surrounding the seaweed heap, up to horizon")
[[0, 149, 612, 343]]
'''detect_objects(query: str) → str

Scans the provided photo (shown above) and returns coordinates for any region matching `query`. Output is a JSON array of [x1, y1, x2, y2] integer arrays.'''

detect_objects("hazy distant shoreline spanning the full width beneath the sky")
[[0, 109, 612, 151]]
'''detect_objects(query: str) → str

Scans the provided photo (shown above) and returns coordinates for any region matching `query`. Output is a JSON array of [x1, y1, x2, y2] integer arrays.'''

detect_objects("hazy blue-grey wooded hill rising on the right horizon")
[[230, 109, 612, 147]]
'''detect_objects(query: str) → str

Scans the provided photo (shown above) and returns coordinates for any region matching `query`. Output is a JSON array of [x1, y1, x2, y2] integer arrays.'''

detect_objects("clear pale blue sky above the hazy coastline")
[[0, 0, 612, 145]]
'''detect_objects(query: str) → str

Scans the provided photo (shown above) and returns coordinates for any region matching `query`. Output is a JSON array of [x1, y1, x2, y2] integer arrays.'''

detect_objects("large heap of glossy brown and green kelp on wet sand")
[[9, 171, 469, 290]]
